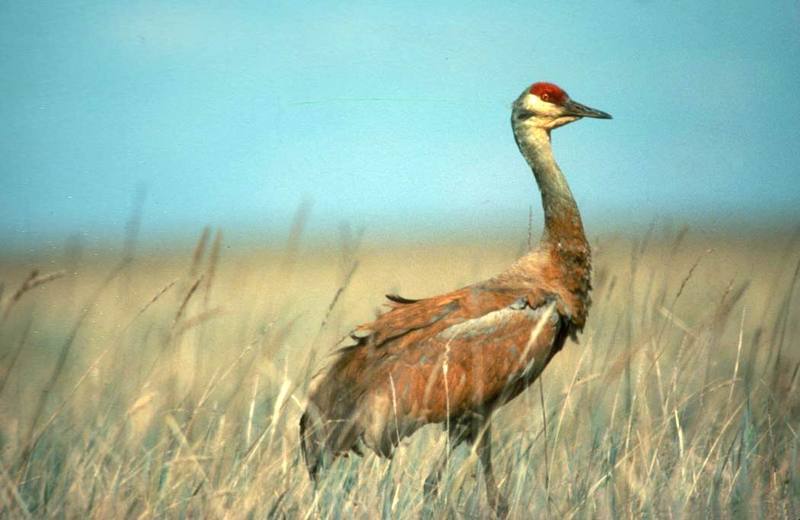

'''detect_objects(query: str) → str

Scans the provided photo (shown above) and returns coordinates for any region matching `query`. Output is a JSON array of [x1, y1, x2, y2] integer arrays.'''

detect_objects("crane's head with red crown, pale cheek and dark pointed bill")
[[511, 82, 611, 131]]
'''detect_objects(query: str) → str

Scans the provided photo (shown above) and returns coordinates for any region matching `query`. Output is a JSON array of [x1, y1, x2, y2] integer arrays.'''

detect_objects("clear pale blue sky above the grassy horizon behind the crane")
[[0, 0, 800, 244]]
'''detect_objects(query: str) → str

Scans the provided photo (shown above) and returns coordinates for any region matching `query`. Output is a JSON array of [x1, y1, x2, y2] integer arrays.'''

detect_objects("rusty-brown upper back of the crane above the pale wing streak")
[[346, 284, 560, 349]]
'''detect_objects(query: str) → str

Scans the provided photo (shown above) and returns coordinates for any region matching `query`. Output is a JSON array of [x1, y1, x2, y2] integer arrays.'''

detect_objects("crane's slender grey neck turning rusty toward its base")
[[512, 118, 586, 242]]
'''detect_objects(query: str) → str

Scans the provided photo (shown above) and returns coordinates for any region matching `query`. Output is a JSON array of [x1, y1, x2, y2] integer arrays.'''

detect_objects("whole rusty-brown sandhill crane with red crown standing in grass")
[[300, 83, 611, 516]]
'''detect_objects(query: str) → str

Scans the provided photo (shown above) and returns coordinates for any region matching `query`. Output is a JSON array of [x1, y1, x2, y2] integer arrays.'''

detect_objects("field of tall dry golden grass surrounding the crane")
[[0, 222, 800, 519]]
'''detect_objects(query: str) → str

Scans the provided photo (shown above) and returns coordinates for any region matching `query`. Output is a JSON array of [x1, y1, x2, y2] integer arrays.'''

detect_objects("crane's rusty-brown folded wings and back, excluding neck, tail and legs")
[[309, 281, 568, 453]]
